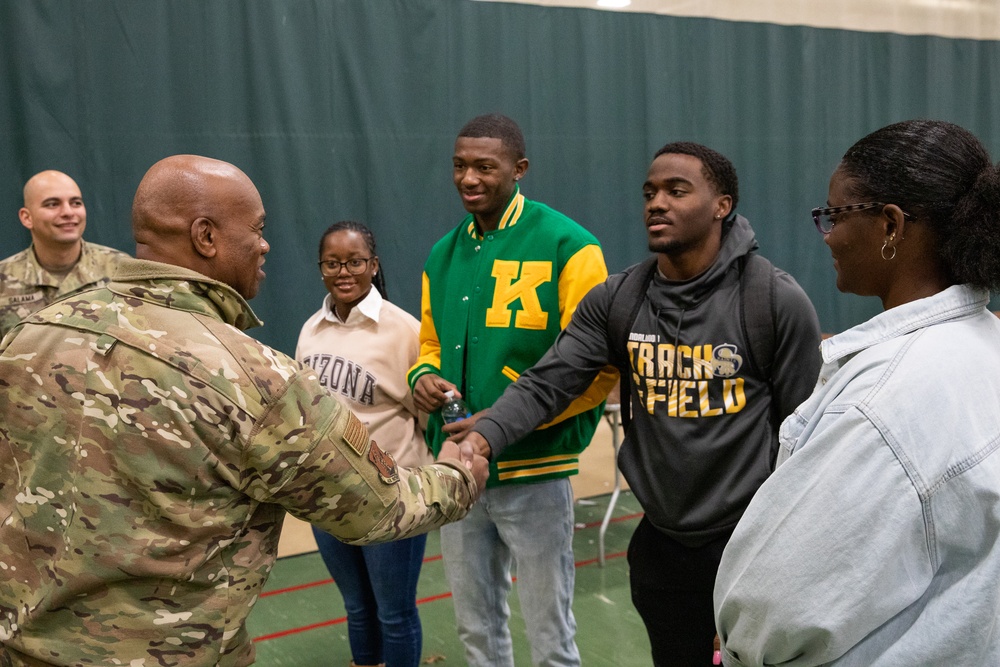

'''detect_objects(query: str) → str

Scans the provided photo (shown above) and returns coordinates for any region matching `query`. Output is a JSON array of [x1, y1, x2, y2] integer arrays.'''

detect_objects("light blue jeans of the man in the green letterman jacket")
[[441, 479, 580, 667]]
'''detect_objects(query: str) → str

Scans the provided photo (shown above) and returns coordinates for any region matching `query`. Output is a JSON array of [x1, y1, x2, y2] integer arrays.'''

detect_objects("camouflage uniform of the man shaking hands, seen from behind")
[[0, 259, 475, 667]]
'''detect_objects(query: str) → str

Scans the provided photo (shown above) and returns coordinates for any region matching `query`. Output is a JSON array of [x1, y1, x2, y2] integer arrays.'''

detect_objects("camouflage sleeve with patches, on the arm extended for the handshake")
[[242, 371, 476, 544]]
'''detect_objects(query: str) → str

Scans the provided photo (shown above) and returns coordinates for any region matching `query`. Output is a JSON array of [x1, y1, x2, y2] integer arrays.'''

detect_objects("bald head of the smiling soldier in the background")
[[17, 170, 87, 253]]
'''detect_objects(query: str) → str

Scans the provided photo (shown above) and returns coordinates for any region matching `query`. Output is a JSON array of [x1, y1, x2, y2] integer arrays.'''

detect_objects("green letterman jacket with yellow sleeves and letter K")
[[407, 189, 618, 487]]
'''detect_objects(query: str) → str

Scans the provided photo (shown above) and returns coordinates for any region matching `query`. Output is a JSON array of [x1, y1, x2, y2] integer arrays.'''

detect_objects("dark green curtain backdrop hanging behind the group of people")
[[0, 0, 1000, 353]]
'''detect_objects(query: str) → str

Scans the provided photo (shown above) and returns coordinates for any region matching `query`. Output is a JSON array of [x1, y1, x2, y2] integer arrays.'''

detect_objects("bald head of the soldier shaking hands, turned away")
[[132, 155, 270, 299]]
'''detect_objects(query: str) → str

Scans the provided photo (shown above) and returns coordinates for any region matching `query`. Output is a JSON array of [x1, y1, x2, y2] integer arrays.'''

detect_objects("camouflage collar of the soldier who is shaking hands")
[[108, 258, 263, 331]]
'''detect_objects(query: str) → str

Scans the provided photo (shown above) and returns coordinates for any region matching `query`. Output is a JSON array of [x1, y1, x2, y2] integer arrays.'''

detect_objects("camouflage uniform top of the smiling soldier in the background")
[[0, 241, 128, 338]]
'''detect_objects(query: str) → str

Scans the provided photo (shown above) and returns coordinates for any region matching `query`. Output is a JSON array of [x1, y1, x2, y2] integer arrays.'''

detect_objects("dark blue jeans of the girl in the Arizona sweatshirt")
[[313, 528, 427, 667]]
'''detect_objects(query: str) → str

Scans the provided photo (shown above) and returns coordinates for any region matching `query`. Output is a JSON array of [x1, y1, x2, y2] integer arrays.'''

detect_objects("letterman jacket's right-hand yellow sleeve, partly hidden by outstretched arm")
[[540, 245, 618, 428]]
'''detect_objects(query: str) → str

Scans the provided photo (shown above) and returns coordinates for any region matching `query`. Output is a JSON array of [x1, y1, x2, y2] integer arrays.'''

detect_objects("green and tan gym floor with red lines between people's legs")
[[248, 417, 650, 667]]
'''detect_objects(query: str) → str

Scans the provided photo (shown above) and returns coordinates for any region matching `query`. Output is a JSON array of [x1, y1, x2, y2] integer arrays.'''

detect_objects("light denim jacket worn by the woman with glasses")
[[715, 286, 1000, 667]]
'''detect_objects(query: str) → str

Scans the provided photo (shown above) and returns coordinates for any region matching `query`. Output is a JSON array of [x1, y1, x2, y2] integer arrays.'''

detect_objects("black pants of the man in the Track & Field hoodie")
[[628, 517, 732, 667]]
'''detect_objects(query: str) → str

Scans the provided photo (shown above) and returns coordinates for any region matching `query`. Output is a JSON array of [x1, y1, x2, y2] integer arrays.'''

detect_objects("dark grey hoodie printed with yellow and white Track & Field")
[[475, 216, 821, 546]]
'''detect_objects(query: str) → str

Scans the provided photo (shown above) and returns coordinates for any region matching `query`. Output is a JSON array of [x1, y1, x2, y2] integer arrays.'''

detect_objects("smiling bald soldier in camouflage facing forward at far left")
[[0, 170, 128, 338]]
